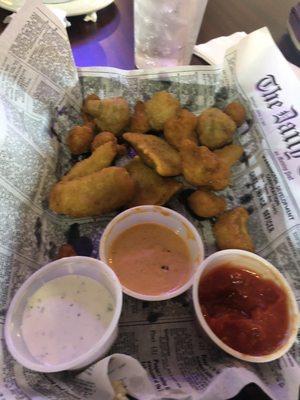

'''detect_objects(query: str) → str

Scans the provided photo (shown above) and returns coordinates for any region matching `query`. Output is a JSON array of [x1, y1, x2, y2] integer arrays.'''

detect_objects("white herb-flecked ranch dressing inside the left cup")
[[21, 275, 115, 365]]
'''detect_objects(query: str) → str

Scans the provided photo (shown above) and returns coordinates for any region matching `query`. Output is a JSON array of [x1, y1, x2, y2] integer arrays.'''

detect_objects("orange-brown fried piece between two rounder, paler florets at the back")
[[164, 109, 198, 150]]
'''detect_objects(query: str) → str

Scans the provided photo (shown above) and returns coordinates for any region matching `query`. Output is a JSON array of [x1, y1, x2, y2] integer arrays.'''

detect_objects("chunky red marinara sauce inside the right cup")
[[199, 264, 289, 356]]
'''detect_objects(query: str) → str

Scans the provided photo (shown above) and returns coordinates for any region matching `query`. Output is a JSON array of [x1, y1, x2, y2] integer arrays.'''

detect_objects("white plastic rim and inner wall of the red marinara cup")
[[193, 250, 299, 363]]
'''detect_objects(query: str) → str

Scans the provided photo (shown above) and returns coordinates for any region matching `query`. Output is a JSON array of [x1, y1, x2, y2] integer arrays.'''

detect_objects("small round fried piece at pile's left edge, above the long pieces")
[[67, 124, 94, 155]]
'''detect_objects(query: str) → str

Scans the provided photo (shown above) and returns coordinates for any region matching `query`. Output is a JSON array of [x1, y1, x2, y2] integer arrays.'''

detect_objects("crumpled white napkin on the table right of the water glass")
[[194, 32, 247, 65]]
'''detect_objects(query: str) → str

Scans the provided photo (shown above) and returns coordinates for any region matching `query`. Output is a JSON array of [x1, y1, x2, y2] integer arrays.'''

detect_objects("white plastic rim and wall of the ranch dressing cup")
[[4, 256, 122, 372]]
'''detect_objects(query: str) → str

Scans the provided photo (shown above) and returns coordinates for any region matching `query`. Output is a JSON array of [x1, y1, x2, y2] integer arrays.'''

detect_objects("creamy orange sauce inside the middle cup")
[[109, 223, 192, 295]]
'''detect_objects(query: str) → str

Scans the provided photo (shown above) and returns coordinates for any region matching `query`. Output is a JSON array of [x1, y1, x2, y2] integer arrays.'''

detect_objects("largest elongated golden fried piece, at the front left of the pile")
[[49, 167, 134, 217]]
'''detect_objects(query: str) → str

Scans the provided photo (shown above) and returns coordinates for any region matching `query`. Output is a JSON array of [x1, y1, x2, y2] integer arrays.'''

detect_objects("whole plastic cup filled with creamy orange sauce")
[[100, 205, 204, 301]]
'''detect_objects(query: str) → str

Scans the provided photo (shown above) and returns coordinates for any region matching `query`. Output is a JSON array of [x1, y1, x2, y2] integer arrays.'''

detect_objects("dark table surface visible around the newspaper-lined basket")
[[0, 0, 300, 400]]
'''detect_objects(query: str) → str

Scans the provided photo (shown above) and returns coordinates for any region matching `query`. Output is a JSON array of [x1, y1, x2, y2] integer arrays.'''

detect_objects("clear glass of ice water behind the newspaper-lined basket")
[[134, 0, 207, 68]]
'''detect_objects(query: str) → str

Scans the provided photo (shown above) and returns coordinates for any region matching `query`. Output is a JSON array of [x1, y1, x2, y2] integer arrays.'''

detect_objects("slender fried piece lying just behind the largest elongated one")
[[62, 142, 117, 181]]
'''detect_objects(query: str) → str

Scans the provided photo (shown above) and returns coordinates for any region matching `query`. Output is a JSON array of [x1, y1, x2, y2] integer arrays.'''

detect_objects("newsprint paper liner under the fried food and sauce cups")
[[0, 0, 300, 400]]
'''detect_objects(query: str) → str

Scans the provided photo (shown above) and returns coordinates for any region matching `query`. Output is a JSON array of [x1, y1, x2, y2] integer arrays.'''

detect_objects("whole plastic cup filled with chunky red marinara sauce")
[[193, 250, 299, 363]]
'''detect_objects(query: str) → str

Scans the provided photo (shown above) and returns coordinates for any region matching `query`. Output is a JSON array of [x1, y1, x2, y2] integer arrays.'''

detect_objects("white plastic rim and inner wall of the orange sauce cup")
[[99, 206, 204, 301]]
